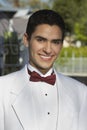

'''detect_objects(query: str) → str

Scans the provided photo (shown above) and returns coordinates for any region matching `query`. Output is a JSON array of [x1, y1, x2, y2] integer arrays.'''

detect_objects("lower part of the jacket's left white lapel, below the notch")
[[12, 86, 37, 130]]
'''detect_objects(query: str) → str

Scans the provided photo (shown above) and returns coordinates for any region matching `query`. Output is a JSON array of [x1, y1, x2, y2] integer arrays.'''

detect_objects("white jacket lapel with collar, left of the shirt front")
[[11, 67, 37, 130]]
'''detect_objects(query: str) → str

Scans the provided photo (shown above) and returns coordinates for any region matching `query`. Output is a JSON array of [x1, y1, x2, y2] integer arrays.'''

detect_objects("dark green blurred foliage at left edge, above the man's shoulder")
[[4, 31, 20, 74]]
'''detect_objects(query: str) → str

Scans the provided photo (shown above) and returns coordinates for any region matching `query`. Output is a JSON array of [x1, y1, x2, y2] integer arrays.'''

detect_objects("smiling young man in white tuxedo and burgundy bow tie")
[[0, 9, 87, 130]]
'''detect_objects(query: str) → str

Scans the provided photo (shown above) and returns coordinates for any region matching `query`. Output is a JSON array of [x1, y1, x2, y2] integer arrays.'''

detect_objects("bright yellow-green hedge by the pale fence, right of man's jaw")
[[55, 46, 87, 66]]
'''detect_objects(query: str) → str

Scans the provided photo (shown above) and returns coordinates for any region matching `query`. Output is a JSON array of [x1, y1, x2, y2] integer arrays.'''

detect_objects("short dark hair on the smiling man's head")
[[26, 9, 65, 40]]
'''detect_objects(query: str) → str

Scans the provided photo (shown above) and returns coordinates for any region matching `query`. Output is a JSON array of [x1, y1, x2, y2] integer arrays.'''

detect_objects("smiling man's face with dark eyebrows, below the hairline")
[[24, 24, 62, 74]]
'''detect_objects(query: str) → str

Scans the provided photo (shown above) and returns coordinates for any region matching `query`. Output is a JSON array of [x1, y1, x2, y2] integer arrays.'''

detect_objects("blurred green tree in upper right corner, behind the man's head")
[[52, 0, 87, 42]]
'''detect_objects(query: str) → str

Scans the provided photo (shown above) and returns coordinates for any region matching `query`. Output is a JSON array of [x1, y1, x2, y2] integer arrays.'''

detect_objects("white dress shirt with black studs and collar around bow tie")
[[28, 65, 58, 130]]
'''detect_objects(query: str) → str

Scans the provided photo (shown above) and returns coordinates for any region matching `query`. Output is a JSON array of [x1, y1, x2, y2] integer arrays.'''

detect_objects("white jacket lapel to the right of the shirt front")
[[54, 72, 78, 130]]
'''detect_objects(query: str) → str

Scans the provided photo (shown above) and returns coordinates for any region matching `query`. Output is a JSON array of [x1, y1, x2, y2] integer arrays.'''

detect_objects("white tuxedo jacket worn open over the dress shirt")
[[0, 66, 87, 130]]
